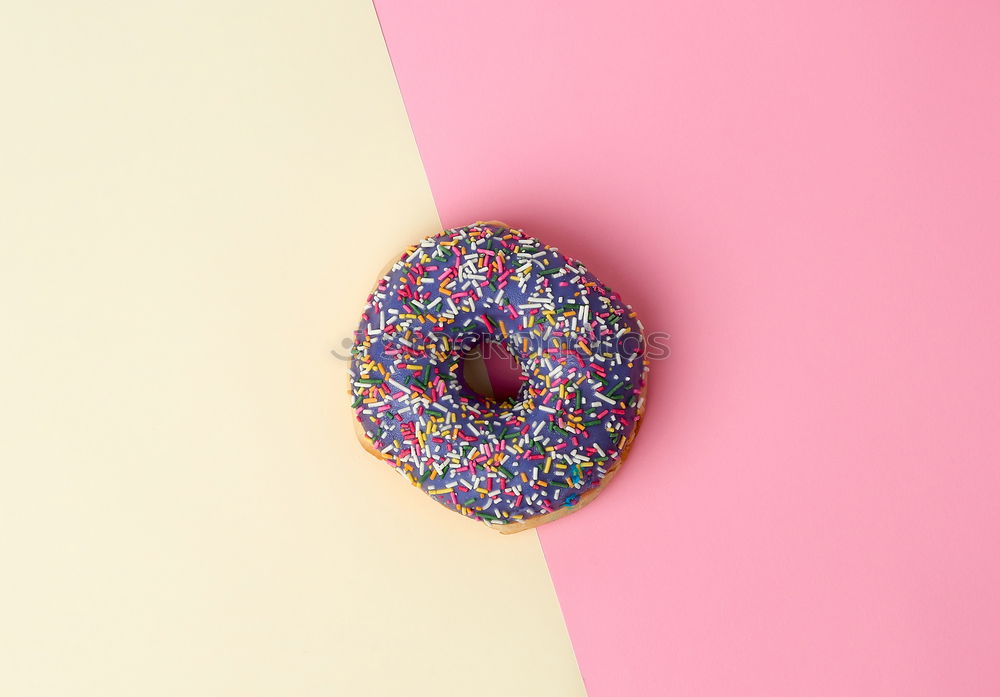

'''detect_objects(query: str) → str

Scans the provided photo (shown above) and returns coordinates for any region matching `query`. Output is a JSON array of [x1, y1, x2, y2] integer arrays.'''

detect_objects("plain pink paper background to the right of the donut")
[[376, 0, 1000, 697]]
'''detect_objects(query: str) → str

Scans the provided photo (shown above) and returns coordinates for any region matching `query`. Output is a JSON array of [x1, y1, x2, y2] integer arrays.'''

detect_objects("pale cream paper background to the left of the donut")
[[0, 0, 583, 697]]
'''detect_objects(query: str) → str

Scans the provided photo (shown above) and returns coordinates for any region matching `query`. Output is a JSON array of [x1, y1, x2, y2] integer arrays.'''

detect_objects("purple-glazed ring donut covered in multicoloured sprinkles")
[[349, 222, 649, 533]]
